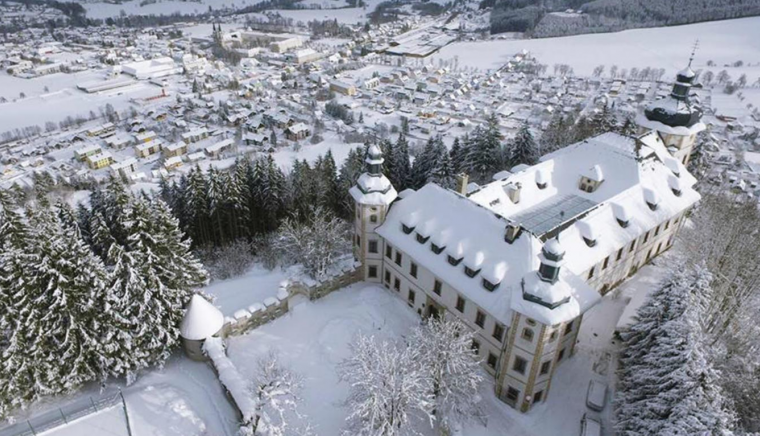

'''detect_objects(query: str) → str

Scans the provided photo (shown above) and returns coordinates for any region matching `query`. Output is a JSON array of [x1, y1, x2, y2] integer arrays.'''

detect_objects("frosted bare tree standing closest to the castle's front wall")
[[410, 318, 484, 434]]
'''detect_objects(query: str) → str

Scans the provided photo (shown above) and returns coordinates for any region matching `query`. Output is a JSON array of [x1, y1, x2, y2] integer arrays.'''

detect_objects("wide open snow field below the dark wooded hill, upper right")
[[434, 17, 760, 76]]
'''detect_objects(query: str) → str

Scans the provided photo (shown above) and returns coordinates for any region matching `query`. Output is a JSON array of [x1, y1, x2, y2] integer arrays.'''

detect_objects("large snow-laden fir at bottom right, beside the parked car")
[[615, 269, 732, 436]]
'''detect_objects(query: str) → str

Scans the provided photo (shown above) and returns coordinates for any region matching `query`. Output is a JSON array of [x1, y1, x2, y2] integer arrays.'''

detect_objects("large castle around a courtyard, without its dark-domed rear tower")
[[350, 130, 699, 411]]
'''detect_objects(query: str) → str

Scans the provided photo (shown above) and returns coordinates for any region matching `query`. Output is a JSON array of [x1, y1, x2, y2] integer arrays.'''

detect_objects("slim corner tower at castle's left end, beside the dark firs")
[[350, 145, 398, 283]]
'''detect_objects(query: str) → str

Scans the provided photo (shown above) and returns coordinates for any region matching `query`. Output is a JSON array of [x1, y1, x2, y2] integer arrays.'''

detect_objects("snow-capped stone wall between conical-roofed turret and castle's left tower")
[[222, 261, 362, 337]]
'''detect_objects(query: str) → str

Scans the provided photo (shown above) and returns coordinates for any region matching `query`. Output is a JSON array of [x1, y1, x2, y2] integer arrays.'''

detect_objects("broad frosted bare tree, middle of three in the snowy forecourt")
[[339, 335, 434, 436]]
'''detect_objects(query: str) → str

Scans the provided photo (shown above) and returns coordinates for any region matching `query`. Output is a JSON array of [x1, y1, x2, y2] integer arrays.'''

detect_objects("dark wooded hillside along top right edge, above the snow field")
[[490, 0, 760, 38]]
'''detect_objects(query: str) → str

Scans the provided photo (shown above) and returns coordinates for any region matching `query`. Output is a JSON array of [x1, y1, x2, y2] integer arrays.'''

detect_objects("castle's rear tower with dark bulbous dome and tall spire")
[[636, 65, 705, 165]]
